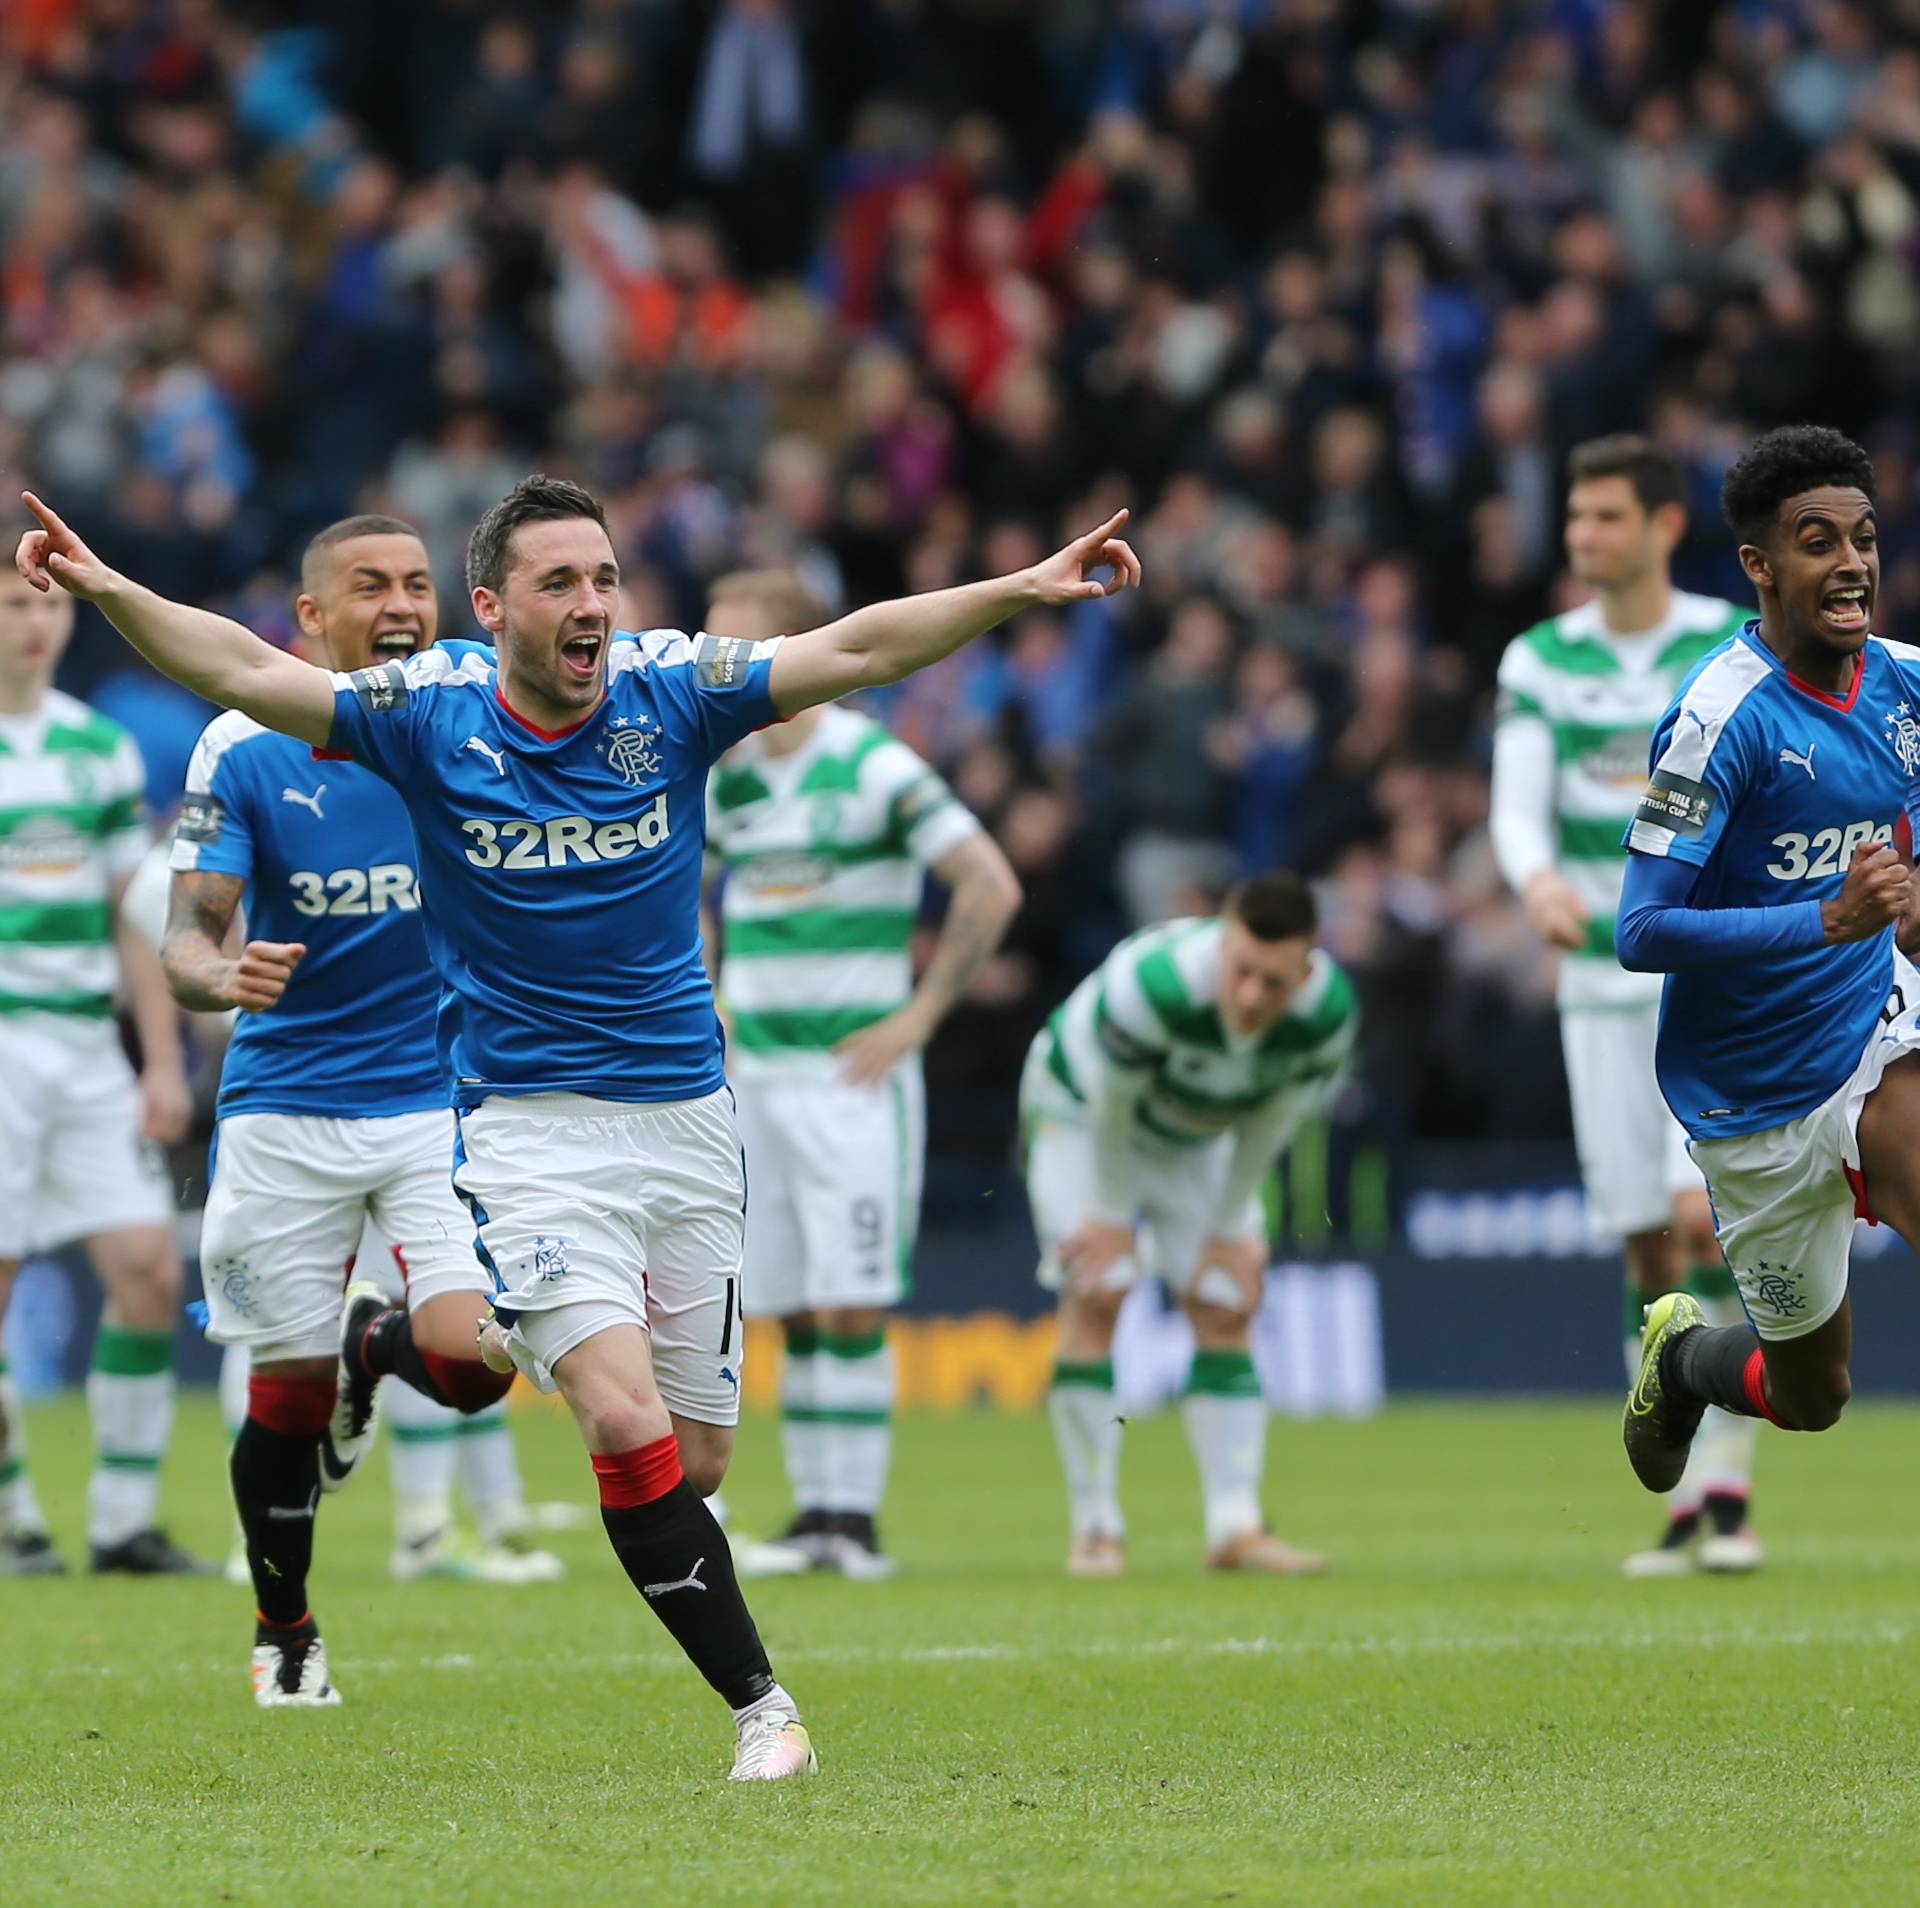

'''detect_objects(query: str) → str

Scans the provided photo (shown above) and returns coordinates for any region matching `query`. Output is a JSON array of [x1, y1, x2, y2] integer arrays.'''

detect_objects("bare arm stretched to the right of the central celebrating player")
[[768, 511, 1140, 716]]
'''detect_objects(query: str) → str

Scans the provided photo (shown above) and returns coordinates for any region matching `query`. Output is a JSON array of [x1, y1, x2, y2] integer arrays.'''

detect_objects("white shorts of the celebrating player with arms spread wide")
[[453, 1088, 747, 1424]]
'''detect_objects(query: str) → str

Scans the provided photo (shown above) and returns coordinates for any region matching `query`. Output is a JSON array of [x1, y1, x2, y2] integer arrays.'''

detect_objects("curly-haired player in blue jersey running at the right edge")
[[1619, 426, 1920, 1491]]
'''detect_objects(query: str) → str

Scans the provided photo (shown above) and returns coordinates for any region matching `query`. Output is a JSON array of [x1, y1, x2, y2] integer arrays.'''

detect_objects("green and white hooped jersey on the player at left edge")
[[0, 691, 148, 1021]]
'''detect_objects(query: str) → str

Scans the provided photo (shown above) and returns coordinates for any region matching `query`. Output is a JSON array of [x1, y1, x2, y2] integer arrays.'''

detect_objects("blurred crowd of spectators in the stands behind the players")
[[0, 0, 1920, 1144]]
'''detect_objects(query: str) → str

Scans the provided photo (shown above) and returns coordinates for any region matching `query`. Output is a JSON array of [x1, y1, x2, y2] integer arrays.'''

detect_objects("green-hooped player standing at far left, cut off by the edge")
[[0, 556, 205, 1576]]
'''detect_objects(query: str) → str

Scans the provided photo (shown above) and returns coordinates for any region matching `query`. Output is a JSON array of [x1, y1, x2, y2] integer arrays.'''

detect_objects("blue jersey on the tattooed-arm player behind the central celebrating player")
[[173, 710, 447, 1119]]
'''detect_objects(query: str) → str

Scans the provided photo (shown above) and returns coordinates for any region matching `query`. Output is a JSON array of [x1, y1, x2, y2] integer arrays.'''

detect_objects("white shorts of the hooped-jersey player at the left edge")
[[0, 1014, 173, 1259]]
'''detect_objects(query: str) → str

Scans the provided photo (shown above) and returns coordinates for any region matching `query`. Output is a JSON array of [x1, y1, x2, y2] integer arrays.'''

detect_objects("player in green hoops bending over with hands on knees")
[[1020, 873, 1359, 1576]]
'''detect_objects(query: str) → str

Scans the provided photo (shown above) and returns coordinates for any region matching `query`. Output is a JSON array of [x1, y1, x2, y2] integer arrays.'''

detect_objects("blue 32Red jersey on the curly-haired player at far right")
[[1626, 622, 1920, 1138]]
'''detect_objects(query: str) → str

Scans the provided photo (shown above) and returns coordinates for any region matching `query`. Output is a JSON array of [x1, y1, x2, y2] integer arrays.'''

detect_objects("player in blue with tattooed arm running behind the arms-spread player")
[[161, 516, 545, 1708]]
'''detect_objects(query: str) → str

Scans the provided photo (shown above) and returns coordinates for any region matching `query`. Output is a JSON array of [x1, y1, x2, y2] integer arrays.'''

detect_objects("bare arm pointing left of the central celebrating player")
[[13, 491, 334, 747]]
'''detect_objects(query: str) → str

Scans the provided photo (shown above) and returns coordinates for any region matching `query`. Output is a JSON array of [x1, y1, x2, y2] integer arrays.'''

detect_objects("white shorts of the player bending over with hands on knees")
[[1020, 1033, 1265, 1298]]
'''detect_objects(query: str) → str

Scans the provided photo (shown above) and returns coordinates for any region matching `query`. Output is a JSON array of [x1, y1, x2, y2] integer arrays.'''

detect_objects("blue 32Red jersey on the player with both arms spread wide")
[[330, 630, 778, 1108]]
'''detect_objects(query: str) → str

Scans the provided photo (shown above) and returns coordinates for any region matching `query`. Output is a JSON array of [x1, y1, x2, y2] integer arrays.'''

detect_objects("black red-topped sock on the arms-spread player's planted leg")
[[593, 1436, 774, 1710]]
